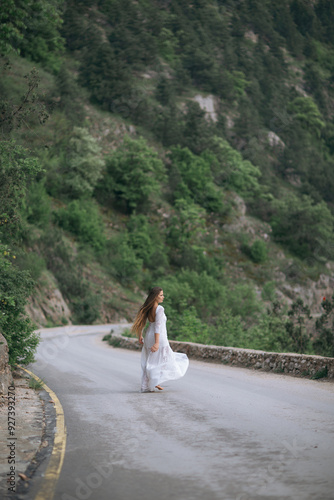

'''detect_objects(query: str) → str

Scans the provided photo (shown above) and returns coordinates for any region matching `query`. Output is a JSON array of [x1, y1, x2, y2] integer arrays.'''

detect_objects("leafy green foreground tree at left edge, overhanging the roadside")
[[0, 140, 41, 365]]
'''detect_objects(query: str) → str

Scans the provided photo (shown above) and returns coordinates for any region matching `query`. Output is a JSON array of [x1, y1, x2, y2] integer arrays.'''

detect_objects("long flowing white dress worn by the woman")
[[141, 304, 189, 392]]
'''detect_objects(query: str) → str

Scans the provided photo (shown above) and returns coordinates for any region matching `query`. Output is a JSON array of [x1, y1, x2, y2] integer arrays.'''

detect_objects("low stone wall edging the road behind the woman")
[[111, 333, 334, 379]]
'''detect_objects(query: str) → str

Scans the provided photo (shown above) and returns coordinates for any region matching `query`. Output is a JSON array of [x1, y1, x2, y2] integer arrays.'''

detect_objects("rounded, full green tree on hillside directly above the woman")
[[98, 136, 164, 213]]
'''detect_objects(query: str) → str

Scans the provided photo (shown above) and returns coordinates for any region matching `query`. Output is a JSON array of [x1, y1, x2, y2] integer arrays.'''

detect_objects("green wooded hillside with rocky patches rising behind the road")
[[0, 0, 334, 363]]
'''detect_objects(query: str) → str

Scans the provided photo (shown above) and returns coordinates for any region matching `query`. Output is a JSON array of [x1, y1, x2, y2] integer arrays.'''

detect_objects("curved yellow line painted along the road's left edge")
[[20, 367, 66, 500]]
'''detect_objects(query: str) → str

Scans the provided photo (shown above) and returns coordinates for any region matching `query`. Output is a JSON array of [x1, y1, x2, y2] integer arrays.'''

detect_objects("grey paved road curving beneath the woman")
[[31, 327, 334, 500]]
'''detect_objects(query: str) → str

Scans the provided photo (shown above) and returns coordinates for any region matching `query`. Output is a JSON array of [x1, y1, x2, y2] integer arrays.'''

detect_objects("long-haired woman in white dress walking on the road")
[[132, 286, 189, 392]]
